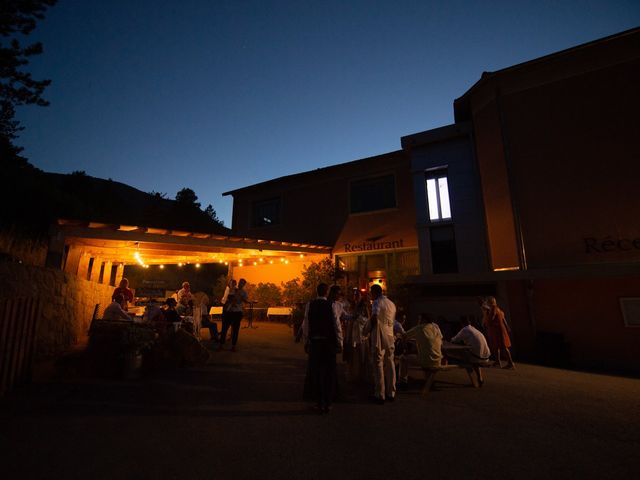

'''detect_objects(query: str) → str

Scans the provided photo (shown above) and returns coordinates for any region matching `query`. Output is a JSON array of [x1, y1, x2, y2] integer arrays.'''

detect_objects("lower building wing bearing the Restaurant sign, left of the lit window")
[[225, 150, 419, 289]]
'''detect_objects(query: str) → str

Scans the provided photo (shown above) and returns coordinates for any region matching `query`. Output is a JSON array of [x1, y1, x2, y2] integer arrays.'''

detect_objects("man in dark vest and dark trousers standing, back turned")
[[302, 283, 342, 413]]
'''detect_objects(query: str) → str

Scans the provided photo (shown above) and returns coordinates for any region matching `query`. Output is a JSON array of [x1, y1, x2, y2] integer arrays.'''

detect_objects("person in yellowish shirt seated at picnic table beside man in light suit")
[[398, 315, 442, 388]]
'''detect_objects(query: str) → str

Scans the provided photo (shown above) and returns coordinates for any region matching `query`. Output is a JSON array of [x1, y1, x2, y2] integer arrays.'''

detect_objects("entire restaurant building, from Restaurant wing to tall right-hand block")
[[227, 29, 640, 370]]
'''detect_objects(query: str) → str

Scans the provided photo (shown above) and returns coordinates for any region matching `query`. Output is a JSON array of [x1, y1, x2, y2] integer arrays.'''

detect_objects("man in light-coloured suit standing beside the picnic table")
[[369, 284, 396, 405]]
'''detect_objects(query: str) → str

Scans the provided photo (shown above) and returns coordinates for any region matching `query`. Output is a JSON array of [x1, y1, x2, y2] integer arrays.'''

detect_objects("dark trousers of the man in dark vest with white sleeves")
[[309, 340, 337, 407]]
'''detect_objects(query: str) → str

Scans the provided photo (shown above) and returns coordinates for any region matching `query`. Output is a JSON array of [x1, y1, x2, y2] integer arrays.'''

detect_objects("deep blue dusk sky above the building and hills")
[[19, 0, 640, 226]]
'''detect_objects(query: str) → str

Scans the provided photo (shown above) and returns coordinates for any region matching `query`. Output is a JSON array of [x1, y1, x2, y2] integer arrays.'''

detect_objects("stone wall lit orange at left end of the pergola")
[[0, 262, 113, 358]]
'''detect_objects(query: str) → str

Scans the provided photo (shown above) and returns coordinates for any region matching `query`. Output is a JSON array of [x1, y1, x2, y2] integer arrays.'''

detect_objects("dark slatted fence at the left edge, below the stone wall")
[[0, 298, 42, 396]]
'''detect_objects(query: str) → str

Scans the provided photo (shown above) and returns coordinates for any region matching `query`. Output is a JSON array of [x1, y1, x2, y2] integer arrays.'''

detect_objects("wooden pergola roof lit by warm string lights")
[[49, 219, 331, 284]]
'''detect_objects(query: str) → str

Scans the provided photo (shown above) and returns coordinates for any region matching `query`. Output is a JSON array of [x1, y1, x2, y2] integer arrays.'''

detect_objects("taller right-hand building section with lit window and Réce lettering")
[[402, 29, 640, 370]]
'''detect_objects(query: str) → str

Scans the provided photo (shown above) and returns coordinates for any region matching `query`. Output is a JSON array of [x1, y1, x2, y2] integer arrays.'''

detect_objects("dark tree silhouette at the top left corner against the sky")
[[0, 0, 57, 164]]
